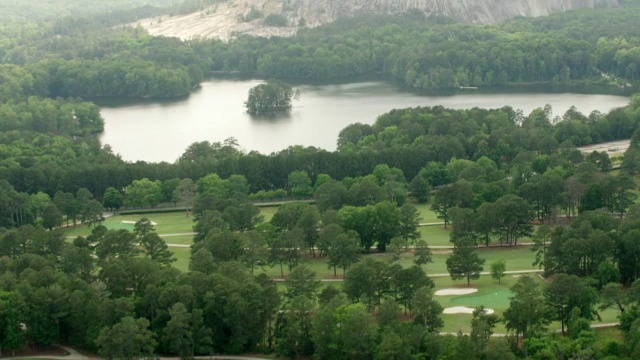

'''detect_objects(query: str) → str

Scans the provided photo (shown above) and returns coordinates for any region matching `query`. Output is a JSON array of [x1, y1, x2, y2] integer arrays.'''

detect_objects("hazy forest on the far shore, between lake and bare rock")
[[0, 1, 640, 100]]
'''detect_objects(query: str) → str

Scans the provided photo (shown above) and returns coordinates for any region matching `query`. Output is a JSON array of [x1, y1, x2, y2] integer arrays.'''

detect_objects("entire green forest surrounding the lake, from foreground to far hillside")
[[0, 0, 640, 359]]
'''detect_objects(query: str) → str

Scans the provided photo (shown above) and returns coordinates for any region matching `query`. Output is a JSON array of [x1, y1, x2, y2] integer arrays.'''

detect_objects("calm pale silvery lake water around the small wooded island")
[[101, 80, 629, 162]]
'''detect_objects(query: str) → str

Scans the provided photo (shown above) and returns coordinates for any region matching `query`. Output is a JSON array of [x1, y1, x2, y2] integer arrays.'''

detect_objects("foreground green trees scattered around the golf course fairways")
[[0, 175, 640, 359]]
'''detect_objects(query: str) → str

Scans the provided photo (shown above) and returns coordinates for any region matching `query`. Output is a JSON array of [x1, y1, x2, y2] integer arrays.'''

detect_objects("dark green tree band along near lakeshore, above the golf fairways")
[[0, 97, 640, 199]]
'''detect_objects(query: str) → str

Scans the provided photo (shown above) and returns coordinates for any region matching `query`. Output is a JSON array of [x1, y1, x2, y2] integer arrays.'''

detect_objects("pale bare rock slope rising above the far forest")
[[132, 0, 620, 40]]
